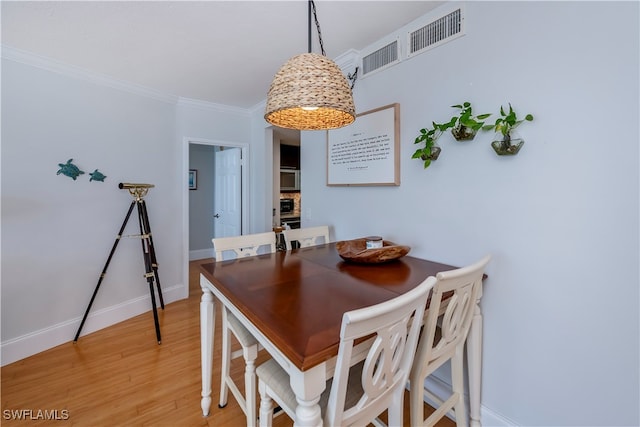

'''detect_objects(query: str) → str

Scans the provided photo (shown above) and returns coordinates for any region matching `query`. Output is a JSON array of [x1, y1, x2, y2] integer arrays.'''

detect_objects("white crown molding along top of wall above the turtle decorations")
[[0, 44, 178, 104]]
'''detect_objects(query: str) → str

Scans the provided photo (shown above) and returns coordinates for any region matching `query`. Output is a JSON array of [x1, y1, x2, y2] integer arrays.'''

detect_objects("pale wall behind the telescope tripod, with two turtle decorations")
[[2, 55, 187, 363]]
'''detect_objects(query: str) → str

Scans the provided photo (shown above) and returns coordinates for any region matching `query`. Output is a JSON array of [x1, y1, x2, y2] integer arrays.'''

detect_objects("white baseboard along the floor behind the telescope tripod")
[[0, 285, 188, 366]]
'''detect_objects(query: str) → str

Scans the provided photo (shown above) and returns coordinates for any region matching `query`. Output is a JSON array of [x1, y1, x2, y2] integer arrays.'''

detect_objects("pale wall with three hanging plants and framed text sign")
[[301, 2, 640, 426]]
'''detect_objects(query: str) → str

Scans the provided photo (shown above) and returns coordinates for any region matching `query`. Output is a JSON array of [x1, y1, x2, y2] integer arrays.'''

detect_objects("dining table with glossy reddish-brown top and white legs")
[[200, 243, 482, 426]]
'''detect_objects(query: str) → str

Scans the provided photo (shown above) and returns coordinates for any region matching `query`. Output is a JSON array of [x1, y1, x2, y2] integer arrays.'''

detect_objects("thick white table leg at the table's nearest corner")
[[289, 363, 326, 427]]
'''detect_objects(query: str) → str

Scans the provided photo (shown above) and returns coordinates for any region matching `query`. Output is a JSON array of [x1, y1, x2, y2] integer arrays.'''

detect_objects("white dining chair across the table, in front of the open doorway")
[[212, 231, 276, 426]]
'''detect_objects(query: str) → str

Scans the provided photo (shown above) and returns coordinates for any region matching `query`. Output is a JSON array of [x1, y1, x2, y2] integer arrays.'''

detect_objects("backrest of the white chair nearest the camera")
[[324, 277, 436, 426]]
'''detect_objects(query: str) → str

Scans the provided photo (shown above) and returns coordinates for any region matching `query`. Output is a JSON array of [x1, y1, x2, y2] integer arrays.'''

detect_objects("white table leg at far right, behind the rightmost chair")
[[467, 299, 482, 427]]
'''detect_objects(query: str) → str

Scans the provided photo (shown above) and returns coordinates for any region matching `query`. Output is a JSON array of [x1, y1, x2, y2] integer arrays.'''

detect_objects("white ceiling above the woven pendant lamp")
[[1, 0, 443, 108]]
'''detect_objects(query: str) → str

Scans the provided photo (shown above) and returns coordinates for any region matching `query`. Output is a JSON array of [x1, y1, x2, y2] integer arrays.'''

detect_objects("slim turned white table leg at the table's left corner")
[[200, 276, 216, 417]]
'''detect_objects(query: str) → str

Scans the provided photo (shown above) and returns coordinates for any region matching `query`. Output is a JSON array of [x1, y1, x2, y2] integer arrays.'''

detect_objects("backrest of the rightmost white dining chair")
[[414, 255, 491, 375]]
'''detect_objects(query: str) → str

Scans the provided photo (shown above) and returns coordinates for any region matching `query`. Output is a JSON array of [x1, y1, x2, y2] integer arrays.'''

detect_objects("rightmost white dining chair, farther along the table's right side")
[[409, 255, 491, 426]]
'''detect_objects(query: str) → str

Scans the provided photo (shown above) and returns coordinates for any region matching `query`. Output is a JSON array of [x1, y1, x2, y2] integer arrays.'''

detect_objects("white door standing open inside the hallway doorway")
[[213, 147, 242, 237]]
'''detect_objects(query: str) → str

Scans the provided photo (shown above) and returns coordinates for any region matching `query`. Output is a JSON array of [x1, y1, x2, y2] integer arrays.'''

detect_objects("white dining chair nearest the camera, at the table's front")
[[256, 277, 436, 427]]
